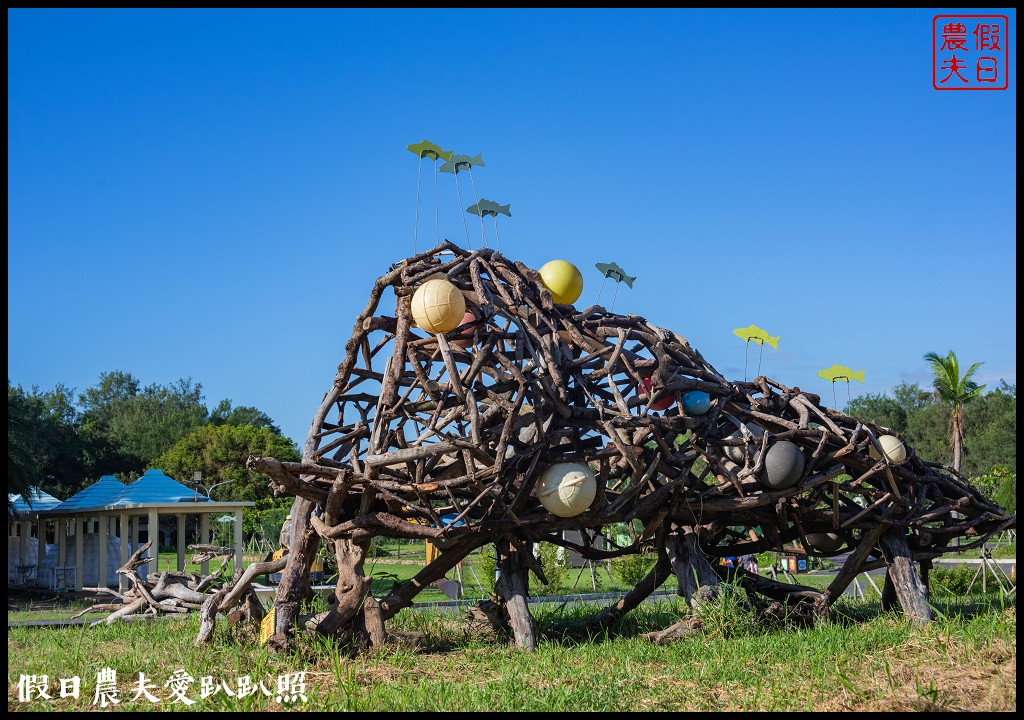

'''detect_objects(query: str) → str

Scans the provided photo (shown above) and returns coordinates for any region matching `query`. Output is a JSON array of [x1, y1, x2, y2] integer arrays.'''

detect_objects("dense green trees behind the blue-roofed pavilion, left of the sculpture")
[[7, 371, 300, 520]]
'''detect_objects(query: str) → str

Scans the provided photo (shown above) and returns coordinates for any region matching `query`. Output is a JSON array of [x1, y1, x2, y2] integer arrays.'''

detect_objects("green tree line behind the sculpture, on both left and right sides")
[[7, 351, 1017, 524]]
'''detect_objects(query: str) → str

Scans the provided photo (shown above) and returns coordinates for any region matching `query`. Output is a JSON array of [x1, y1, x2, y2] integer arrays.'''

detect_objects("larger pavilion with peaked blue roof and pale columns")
[[20, 469, 255, 590]]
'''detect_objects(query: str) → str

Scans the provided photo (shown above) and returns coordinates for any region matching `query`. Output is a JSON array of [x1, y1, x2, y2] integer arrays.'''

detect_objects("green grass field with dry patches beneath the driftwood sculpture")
[[7, 593, 1016, 712]]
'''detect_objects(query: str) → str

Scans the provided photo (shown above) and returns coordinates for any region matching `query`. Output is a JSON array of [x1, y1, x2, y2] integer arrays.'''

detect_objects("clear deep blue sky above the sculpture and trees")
[[7, 8, 1019, 444]]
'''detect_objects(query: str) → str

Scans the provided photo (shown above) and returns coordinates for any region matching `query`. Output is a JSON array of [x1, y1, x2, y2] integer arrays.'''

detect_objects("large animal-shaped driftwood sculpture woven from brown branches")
[[200, 242, 1016, 649]]
